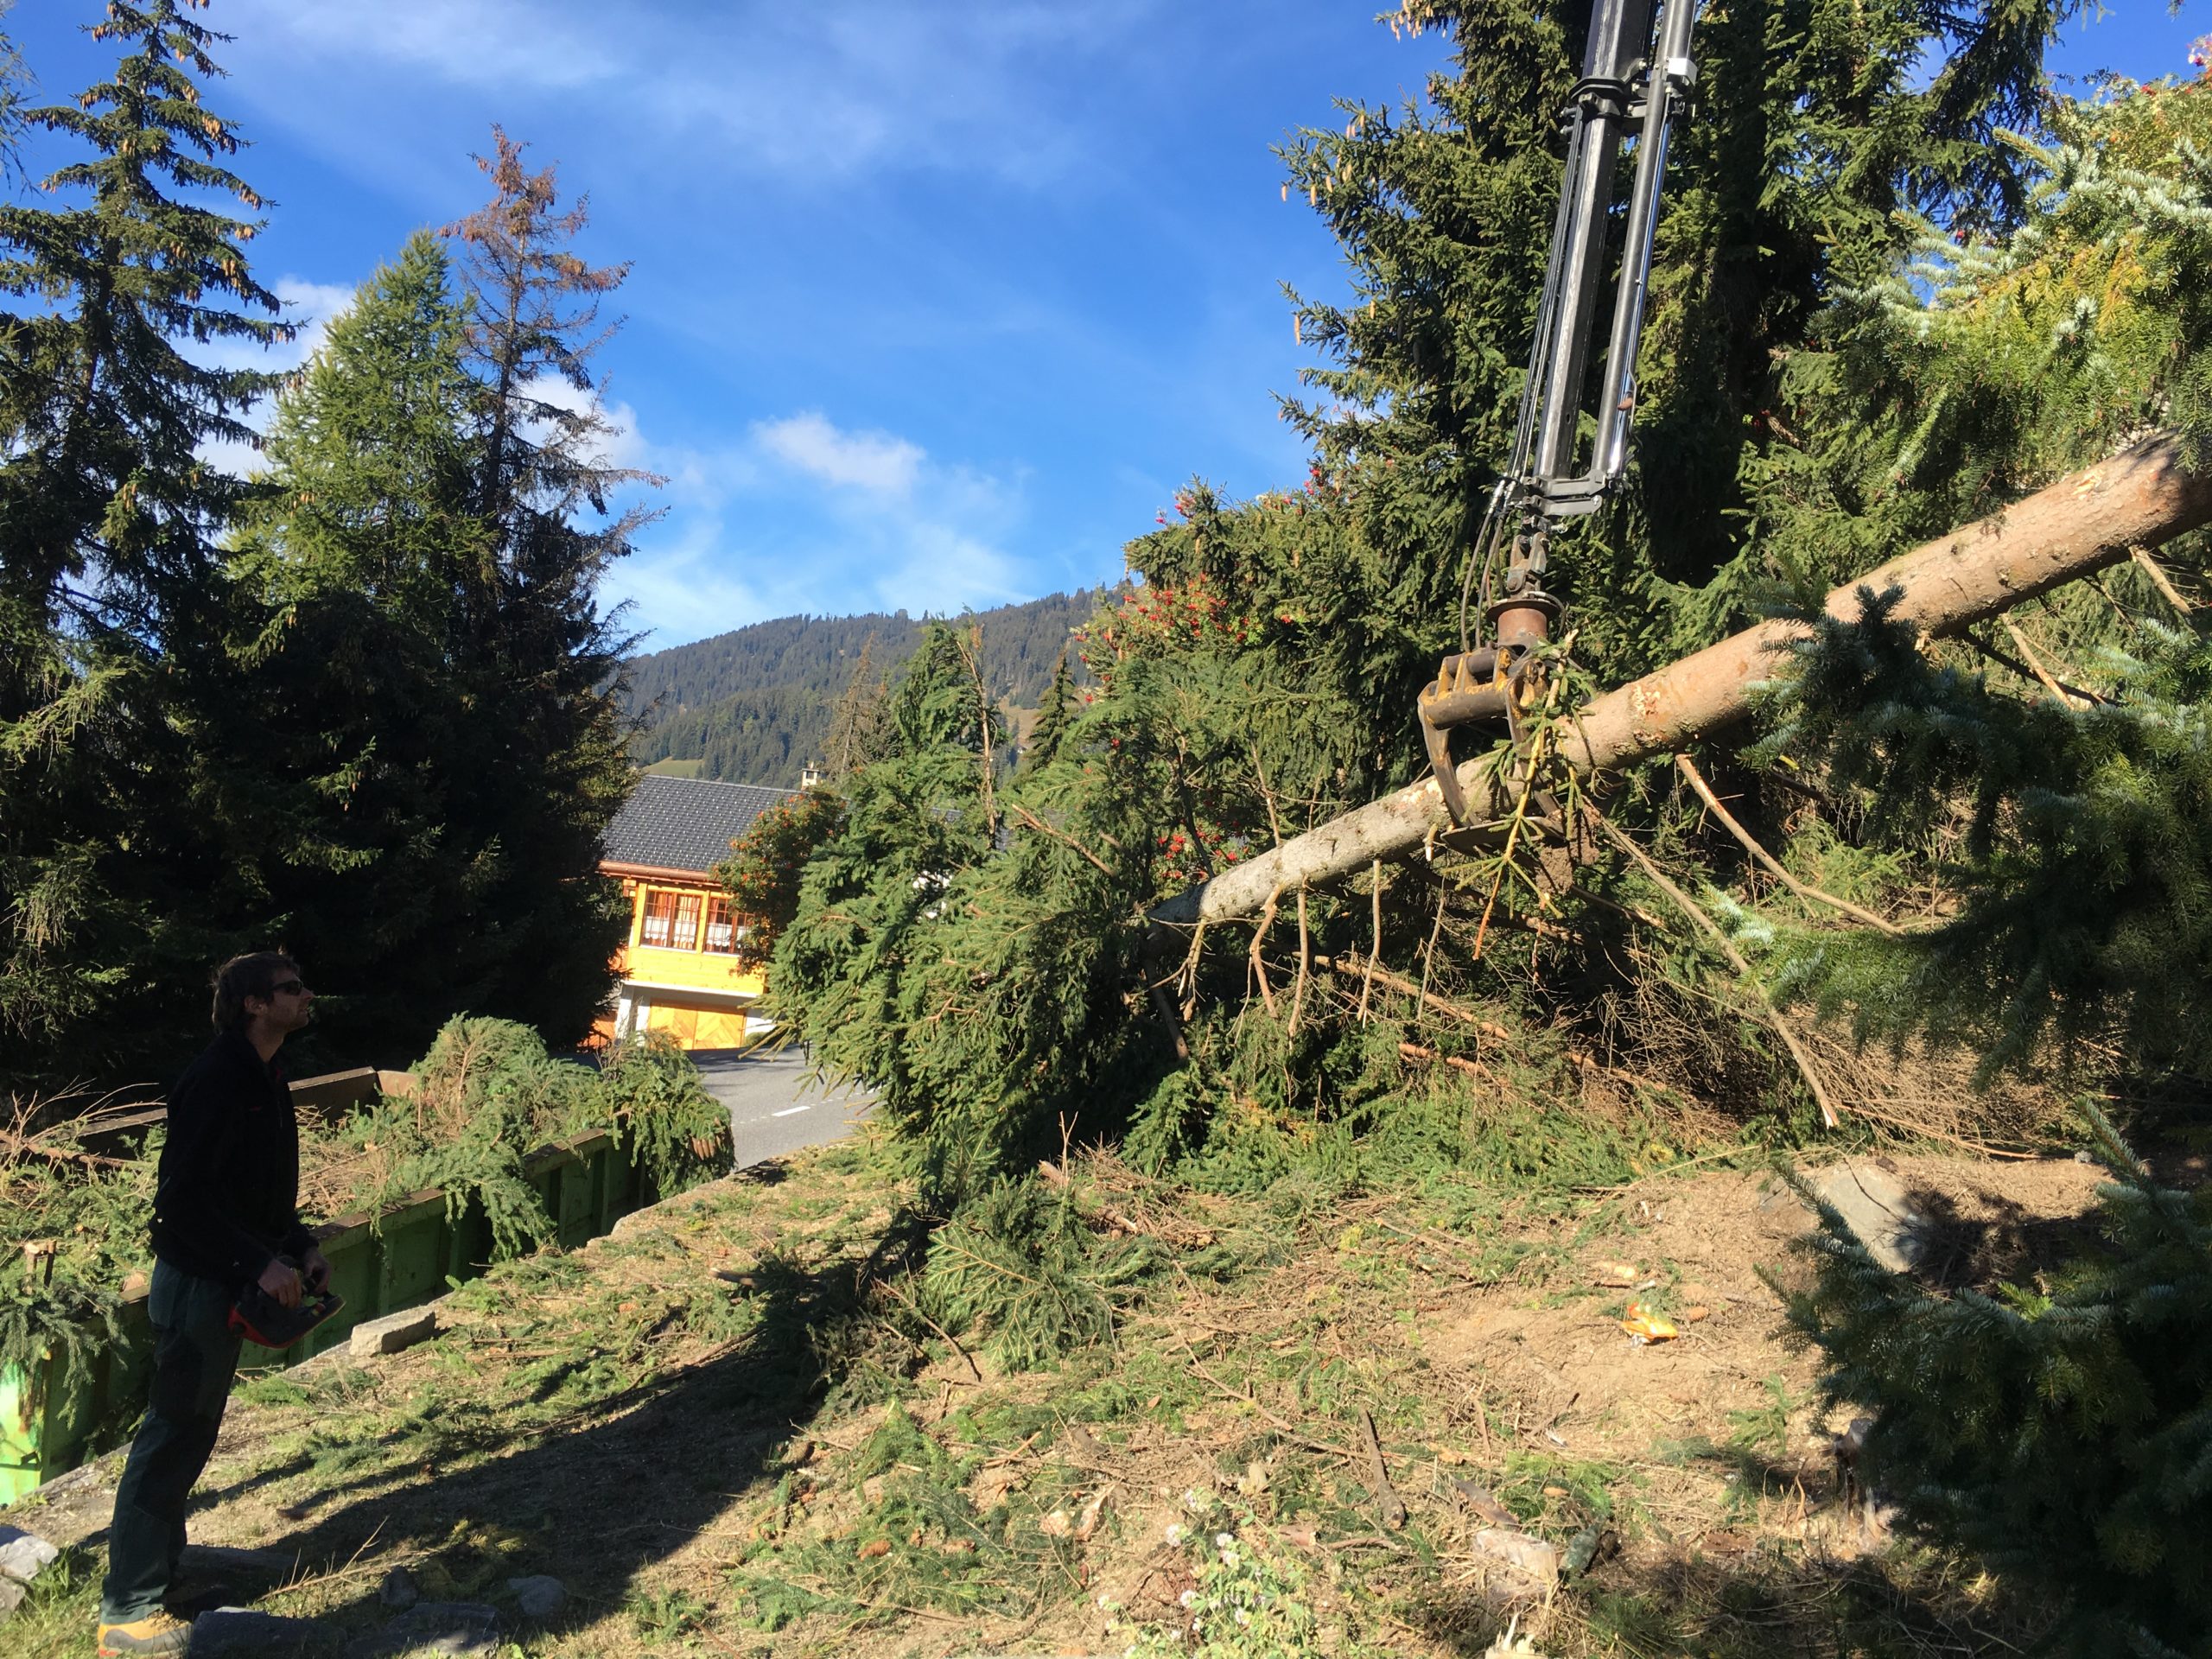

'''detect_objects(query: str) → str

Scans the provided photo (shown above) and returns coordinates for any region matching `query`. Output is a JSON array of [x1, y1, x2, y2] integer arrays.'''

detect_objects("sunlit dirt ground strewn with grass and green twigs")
[[7, 1141, 2104, 1659]]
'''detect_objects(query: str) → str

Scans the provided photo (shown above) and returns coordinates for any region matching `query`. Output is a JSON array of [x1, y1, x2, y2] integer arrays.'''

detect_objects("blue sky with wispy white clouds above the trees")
[[7, 0, 2212, 646]]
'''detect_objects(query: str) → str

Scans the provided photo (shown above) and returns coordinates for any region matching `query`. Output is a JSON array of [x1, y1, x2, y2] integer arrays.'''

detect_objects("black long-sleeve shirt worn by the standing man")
[[153, 1031, 312, 1289]]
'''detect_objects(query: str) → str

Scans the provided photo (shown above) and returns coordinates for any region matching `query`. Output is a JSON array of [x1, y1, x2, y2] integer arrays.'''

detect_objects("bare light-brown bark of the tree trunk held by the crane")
[[1150, 435, 2212, 923]]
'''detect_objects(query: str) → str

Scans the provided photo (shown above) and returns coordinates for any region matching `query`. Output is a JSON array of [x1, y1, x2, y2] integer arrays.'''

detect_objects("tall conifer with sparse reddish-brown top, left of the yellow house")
[[424, 128, 661, 1042]]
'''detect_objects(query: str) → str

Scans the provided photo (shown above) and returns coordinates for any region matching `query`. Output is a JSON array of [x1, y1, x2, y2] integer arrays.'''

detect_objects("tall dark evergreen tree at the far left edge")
[[0, 0, 289, 1073]]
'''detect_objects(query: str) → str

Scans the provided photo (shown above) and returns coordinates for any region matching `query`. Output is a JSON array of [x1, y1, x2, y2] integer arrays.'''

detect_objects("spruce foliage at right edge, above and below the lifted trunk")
[[1750, 84, 2212, 1075]]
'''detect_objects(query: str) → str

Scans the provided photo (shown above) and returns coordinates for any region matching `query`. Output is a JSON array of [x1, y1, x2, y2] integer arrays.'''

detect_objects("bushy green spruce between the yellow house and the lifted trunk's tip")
[[765, 624, 1130, 1205]]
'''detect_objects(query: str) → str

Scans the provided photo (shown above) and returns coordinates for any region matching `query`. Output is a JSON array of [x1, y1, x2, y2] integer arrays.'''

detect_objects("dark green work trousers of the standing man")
[[99, 1261, 238, 1624]]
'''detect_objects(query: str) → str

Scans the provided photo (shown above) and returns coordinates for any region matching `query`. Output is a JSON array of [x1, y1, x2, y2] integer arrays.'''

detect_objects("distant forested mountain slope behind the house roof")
[[628, 588, 1106, 787]]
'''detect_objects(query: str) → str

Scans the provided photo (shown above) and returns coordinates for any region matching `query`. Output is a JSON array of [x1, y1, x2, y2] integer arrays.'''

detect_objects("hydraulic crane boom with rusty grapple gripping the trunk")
[[1421, 0, 1699, 823]]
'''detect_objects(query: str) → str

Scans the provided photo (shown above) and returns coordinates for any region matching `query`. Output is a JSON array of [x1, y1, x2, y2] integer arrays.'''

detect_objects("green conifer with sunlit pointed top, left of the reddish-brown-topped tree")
[[190, 232, 515, 1059]]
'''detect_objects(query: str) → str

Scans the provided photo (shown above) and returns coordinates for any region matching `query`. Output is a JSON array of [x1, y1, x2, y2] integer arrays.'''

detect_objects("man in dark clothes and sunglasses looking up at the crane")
[[99, 951, 329, 1659]]
